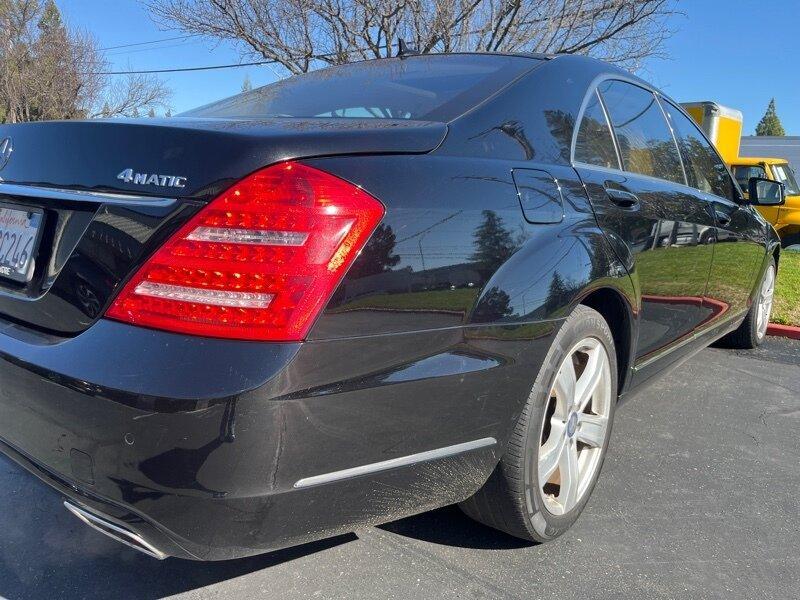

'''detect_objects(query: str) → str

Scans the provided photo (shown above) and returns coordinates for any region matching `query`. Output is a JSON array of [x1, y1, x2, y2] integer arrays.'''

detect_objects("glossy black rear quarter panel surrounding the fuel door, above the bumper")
[[311, 155, 627, 339]]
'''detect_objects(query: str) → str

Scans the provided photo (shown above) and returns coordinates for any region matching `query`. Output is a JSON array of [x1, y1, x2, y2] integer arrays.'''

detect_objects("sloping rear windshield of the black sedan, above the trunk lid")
[[181, 54, 539, 122]]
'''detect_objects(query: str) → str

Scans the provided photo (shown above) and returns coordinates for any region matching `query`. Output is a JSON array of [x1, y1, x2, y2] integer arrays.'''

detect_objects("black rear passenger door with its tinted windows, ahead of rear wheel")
[[574, 80, 714, 359]]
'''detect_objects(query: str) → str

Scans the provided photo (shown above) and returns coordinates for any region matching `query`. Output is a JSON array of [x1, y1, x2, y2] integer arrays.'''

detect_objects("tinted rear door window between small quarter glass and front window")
[[599, 81, 686, 183]]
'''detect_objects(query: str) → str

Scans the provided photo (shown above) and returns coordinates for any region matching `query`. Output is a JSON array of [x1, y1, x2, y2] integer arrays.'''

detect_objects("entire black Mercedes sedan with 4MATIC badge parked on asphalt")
[[0, 54, 783, 560]]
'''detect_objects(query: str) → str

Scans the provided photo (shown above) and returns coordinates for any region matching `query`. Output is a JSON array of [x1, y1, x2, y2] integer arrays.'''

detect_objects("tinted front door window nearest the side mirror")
[[664, 102, 734, 200]]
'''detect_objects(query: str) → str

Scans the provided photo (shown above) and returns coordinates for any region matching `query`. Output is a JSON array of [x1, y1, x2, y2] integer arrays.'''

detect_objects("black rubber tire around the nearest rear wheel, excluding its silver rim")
[[460, 305, 617, 542]]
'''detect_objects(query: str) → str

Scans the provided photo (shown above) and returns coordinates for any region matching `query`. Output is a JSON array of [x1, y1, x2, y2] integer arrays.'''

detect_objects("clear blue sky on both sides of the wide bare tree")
[[57, 0, 800, 135]]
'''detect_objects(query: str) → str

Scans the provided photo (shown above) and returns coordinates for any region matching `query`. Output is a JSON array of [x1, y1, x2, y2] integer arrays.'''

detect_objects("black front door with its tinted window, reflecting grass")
[[664, 102, 766, 322]]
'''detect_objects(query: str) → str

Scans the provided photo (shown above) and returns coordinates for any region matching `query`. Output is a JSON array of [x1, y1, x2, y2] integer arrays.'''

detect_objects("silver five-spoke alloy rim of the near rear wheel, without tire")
[[537, 337, 612, 515]]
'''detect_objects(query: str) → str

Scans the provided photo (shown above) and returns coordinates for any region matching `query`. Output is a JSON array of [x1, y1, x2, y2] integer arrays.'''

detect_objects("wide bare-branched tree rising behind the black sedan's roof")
[[142, 0, 676, 73]]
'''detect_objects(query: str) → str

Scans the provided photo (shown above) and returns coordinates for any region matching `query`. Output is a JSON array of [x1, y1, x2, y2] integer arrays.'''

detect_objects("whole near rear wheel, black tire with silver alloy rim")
[[461, 306, 617, 542]]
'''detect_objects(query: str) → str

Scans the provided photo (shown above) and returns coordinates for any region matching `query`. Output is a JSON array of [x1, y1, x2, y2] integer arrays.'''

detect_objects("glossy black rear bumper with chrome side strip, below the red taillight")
[[0, 320, 557, 560]]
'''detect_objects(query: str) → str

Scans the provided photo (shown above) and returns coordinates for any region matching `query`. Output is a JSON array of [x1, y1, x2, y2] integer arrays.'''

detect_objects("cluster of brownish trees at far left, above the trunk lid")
[[0, 0, 169, 123]]
